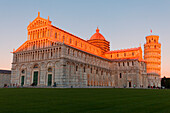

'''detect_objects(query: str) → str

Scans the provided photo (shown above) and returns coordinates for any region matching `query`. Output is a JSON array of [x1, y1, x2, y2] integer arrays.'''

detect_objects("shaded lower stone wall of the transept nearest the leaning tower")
[[111, 60, 148, 88]]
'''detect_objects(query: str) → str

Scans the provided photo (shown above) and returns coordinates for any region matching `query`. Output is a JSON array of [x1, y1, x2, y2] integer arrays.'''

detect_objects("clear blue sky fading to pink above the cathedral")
[[0, 0, 170, 77]]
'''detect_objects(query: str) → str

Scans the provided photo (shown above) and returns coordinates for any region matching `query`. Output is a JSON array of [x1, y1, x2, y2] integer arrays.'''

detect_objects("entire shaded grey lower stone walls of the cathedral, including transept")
[[12, 43, 146, 87]]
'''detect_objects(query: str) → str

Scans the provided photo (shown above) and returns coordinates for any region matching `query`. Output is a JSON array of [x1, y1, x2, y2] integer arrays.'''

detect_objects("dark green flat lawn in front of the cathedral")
[[0, 88, 170, 113]]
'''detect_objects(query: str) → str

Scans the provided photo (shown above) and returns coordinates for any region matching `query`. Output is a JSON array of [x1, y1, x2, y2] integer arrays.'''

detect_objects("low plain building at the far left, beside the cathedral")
[[0, 70, 11, 87]]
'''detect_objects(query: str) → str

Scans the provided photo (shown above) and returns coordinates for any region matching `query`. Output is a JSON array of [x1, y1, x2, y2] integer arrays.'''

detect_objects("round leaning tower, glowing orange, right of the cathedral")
[[144, 35, 161, 86]]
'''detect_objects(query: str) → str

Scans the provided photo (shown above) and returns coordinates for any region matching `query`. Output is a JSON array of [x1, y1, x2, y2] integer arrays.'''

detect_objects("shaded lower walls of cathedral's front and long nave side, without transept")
[[12, 43, 113, 86]]
